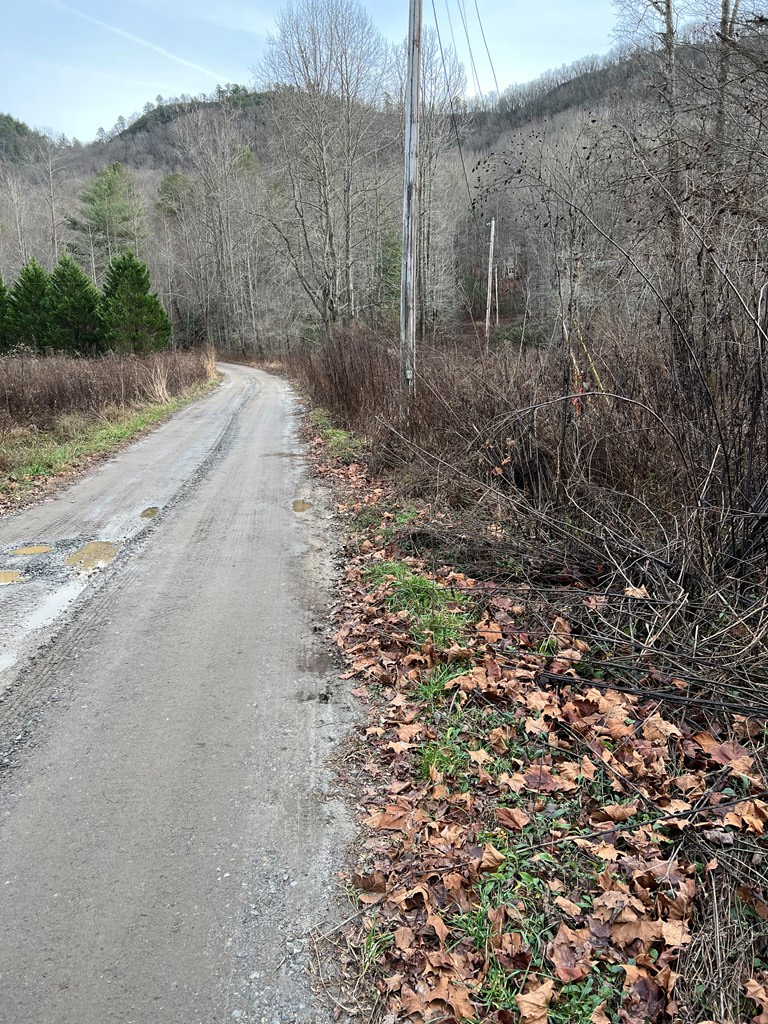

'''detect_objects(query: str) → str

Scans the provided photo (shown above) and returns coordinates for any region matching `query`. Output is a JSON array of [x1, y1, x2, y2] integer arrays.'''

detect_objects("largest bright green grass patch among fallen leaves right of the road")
[[367, 562, 471, 648]]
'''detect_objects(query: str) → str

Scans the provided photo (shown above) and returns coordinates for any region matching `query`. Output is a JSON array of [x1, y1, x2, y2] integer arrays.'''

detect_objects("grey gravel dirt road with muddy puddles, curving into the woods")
[[0, 367, 349, 1024]]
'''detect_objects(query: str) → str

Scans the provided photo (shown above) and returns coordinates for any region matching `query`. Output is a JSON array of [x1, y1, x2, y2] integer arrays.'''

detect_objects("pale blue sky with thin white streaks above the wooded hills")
[[0, 0, 613, 141]]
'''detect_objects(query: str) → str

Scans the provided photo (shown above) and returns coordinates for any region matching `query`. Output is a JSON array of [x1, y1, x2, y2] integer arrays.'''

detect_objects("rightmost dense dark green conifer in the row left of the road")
[[98, 252, 171, 352]]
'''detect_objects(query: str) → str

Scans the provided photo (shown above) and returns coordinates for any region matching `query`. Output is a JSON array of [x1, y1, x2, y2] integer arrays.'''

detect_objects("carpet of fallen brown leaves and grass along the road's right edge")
[[307, 440, 768, 1024]]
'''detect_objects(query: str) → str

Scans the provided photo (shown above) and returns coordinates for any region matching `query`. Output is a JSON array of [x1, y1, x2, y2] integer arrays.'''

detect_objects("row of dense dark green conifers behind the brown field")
[[0, 251, 171, 356]]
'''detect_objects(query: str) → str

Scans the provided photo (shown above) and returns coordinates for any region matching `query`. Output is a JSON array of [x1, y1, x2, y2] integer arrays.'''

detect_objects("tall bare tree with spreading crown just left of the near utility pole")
[[258, 0, 390, 331]]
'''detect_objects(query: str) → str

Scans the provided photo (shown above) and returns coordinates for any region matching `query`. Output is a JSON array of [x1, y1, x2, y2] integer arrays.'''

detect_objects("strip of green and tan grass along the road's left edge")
[[0, 381, 217, 493]]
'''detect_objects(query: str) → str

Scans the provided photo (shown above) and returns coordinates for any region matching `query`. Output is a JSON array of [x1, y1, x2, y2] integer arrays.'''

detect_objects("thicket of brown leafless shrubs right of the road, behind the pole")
[[290, 325, 768, 589]]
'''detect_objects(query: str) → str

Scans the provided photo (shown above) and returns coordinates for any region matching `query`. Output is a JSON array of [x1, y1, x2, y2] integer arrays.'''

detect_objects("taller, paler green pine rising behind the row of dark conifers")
[[68, 164, 143, 280]]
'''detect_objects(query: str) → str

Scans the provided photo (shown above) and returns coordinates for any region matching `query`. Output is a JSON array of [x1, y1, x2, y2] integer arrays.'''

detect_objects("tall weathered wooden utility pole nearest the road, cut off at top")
[[400, 0, 422, 426]]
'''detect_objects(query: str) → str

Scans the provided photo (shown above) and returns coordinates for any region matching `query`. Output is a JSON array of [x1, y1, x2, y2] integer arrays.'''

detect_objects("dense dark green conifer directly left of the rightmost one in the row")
[[45, 253, 103, 355]]
